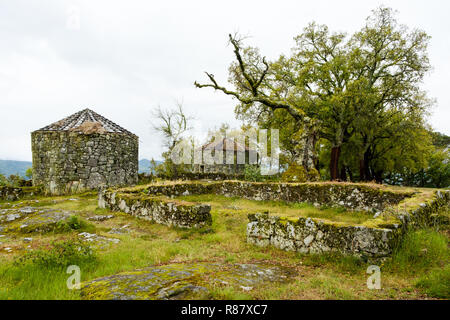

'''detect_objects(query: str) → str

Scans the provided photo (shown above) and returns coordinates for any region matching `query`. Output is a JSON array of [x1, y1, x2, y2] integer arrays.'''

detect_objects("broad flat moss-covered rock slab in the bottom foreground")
[[81, 262, 293, 300]]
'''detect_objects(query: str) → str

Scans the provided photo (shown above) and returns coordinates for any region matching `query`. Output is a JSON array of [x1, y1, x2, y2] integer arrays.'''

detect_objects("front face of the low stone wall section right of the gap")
[[247, 214, 402, 258]]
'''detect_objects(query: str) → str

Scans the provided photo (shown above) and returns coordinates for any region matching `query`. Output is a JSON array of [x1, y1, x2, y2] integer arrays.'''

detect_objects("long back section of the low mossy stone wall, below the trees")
[[130, 181, 413, 212]]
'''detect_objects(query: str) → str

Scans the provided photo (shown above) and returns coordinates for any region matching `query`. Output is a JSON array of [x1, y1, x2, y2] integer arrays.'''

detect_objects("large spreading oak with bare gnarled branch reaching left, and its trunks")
[[195, 7, 430, 180]]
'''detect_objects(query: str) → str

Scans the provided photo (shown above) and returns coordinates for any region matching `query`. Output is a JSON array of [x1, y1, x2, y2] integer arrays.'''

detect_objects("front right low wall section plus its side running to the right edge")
[[247, 190, 450, 258]]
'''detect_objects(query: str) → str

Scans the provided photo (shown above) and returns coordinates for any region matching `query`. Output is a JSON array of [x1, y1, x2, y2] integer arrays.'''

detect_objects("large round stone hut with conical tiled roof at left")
[[31, 109, 139, 194]]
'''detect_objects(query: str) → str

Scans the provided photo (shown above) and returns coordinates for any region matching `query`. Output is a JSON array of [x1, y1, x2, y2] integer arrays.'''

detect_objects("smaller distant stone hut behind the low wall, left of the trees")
[[193, 138, 259, 175]]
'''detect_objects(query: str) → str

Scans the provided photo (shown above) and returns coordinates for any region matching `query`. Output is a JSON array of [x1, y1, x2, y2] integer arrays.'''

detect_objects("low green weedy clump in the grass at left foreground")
[[14, 238, 97, 268]]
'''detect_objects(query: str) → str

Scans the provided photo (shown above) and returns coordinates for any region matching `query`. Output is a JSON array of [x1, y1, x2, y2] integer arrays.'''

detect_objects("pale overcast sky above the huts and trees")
[[0, 0, 450, 160]]
